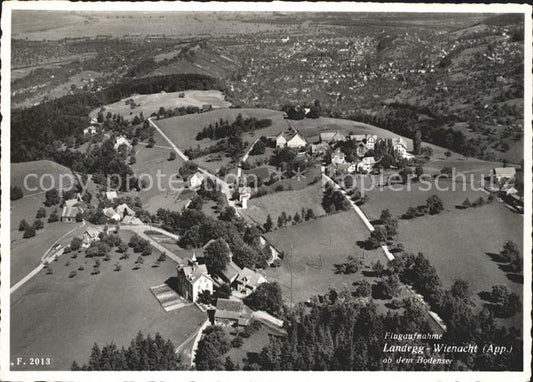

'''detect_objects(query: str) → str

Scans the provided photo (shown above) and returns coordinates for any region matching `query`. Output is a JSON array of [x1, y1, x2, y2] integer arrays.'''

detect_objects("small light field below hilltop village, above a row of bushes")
[[242, 182, 326, 225]]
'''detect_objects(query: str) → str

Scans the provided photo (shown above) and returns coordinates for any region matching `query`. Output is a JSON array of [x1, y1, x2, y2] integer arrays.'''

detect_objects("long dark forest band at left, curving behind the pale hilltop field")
[[11, 74, 220, 162]]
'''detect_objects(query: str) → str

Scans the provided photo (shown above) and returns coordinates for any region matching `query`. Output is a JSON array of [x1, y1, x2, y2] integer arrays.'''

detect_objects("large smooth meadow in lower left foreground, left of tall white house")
[[11, 233, 206, 370]]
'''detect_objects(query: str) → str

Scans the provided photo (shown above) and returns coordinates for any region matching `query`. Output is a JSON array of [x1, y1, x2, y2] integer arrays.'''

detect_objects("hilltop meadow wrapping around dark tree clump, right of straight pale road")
[[154, 109, 287, 150]]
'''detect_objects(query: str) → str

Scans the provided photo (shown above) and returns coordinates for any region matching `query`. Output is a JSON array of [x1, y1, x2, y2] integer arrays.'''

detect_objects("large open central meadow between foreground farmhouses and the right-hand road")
[[265, 211, 386, 302]]
